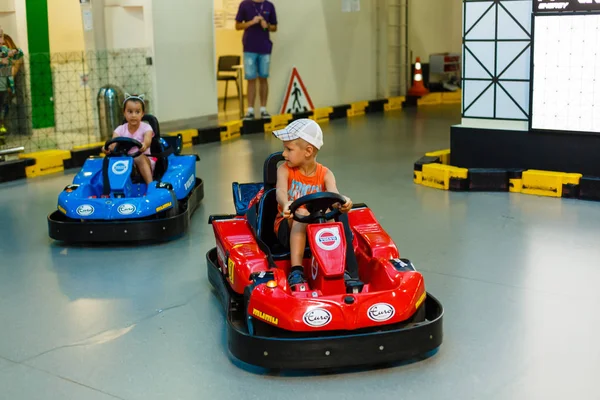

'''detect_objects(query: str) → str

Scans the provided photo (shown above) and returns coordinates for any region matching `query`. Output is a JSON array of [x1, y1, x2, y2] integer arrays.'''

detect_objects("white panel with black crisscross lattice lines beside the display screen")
[[463, 0, 532, 121]]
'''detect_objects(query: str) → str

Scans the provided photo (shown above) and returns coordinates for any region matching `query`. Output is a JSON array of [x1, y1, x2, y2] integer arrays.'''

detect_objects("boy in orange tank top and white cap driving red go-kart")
[[273, 119, 352, 287]]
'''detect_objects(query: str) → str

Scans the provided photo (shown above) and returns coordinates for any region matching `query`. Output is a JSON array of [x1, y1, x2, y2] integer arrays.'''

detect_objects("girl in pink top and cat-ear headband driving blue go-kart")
[[102, 93, 156, 185]]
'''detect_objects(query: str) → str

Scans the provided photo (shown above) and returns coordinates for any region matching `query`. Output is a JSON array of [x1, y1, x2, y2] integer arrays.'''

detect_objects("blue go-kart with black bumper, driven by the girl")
[[48, 114, 204, 243]]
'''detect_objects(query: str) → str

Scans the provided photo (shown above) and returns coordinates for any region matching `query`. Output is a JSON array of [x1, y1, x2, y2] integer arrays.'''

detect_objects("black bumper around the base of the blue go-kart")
[[48, 178, 204, 243]]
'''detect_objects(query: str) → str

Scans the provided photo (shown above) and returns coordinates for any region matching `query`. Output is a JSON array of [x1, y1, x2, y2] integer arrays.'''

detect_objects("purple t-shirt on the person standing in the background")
[[235, 0, 277, 54]]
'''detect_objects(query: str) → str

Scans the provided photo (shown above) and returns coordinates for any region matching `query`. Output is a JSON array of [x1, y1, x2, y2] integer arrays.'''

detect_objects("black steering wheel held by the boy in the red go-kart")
[[290, 192, 346, 224]]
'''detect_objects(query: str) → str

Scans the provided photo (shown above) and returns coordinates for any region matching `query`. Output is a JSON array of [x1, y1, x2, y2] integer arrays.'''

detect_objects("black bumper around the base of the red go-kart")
[[206, 249, 444, 370]]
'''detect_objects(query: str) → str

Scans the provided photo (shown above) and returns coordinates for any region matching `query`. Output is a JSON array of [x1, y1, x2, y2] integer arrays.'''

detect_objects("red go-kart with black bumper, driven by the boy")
[[206, 153, 443, 369]]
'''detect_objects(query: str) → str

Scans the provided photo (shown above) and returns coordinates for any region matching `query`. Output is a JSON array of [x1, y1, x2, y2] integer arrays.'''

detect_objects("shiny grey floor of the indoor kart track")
[[0, 107, 600, 400]]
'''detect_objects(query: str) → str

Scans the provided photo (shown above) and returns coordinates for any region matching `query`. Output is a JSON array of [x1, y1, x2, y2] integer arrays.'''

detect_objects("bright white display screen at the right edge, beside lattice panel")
[[531, 14, 600, 133]]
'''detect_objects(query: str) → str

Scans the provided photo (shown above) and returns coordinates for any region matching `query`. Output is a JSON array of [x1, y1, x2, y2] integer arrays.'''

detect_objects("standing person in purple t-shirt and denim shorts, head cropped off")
[[235, 0, 277, 119]]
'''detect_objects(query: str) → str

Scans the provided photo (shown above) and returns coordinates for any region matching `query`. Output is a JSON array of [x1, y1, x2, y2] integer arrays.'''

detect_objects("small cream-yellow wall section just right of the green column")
[[48, 0, 85, 53]]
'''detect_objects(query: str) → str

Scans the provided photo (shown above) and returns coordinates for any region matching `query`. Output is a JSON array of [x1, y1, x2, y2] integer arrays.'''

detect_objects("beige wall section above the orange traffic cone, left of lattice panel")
[[408, 0, 462, 63]]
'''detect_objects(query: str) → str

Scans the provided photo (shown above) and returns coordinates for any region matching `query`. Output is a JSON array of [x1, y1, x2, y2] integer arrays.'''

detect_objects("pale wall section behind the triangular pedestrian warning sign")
[[268, 0, 376, 113]]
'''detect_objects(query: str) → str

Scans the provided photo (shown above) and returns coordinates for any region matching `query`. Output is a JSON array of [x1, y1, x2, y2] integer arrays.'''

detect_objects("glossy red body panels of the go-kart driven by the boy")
[[212, 208, 426, 332]]
